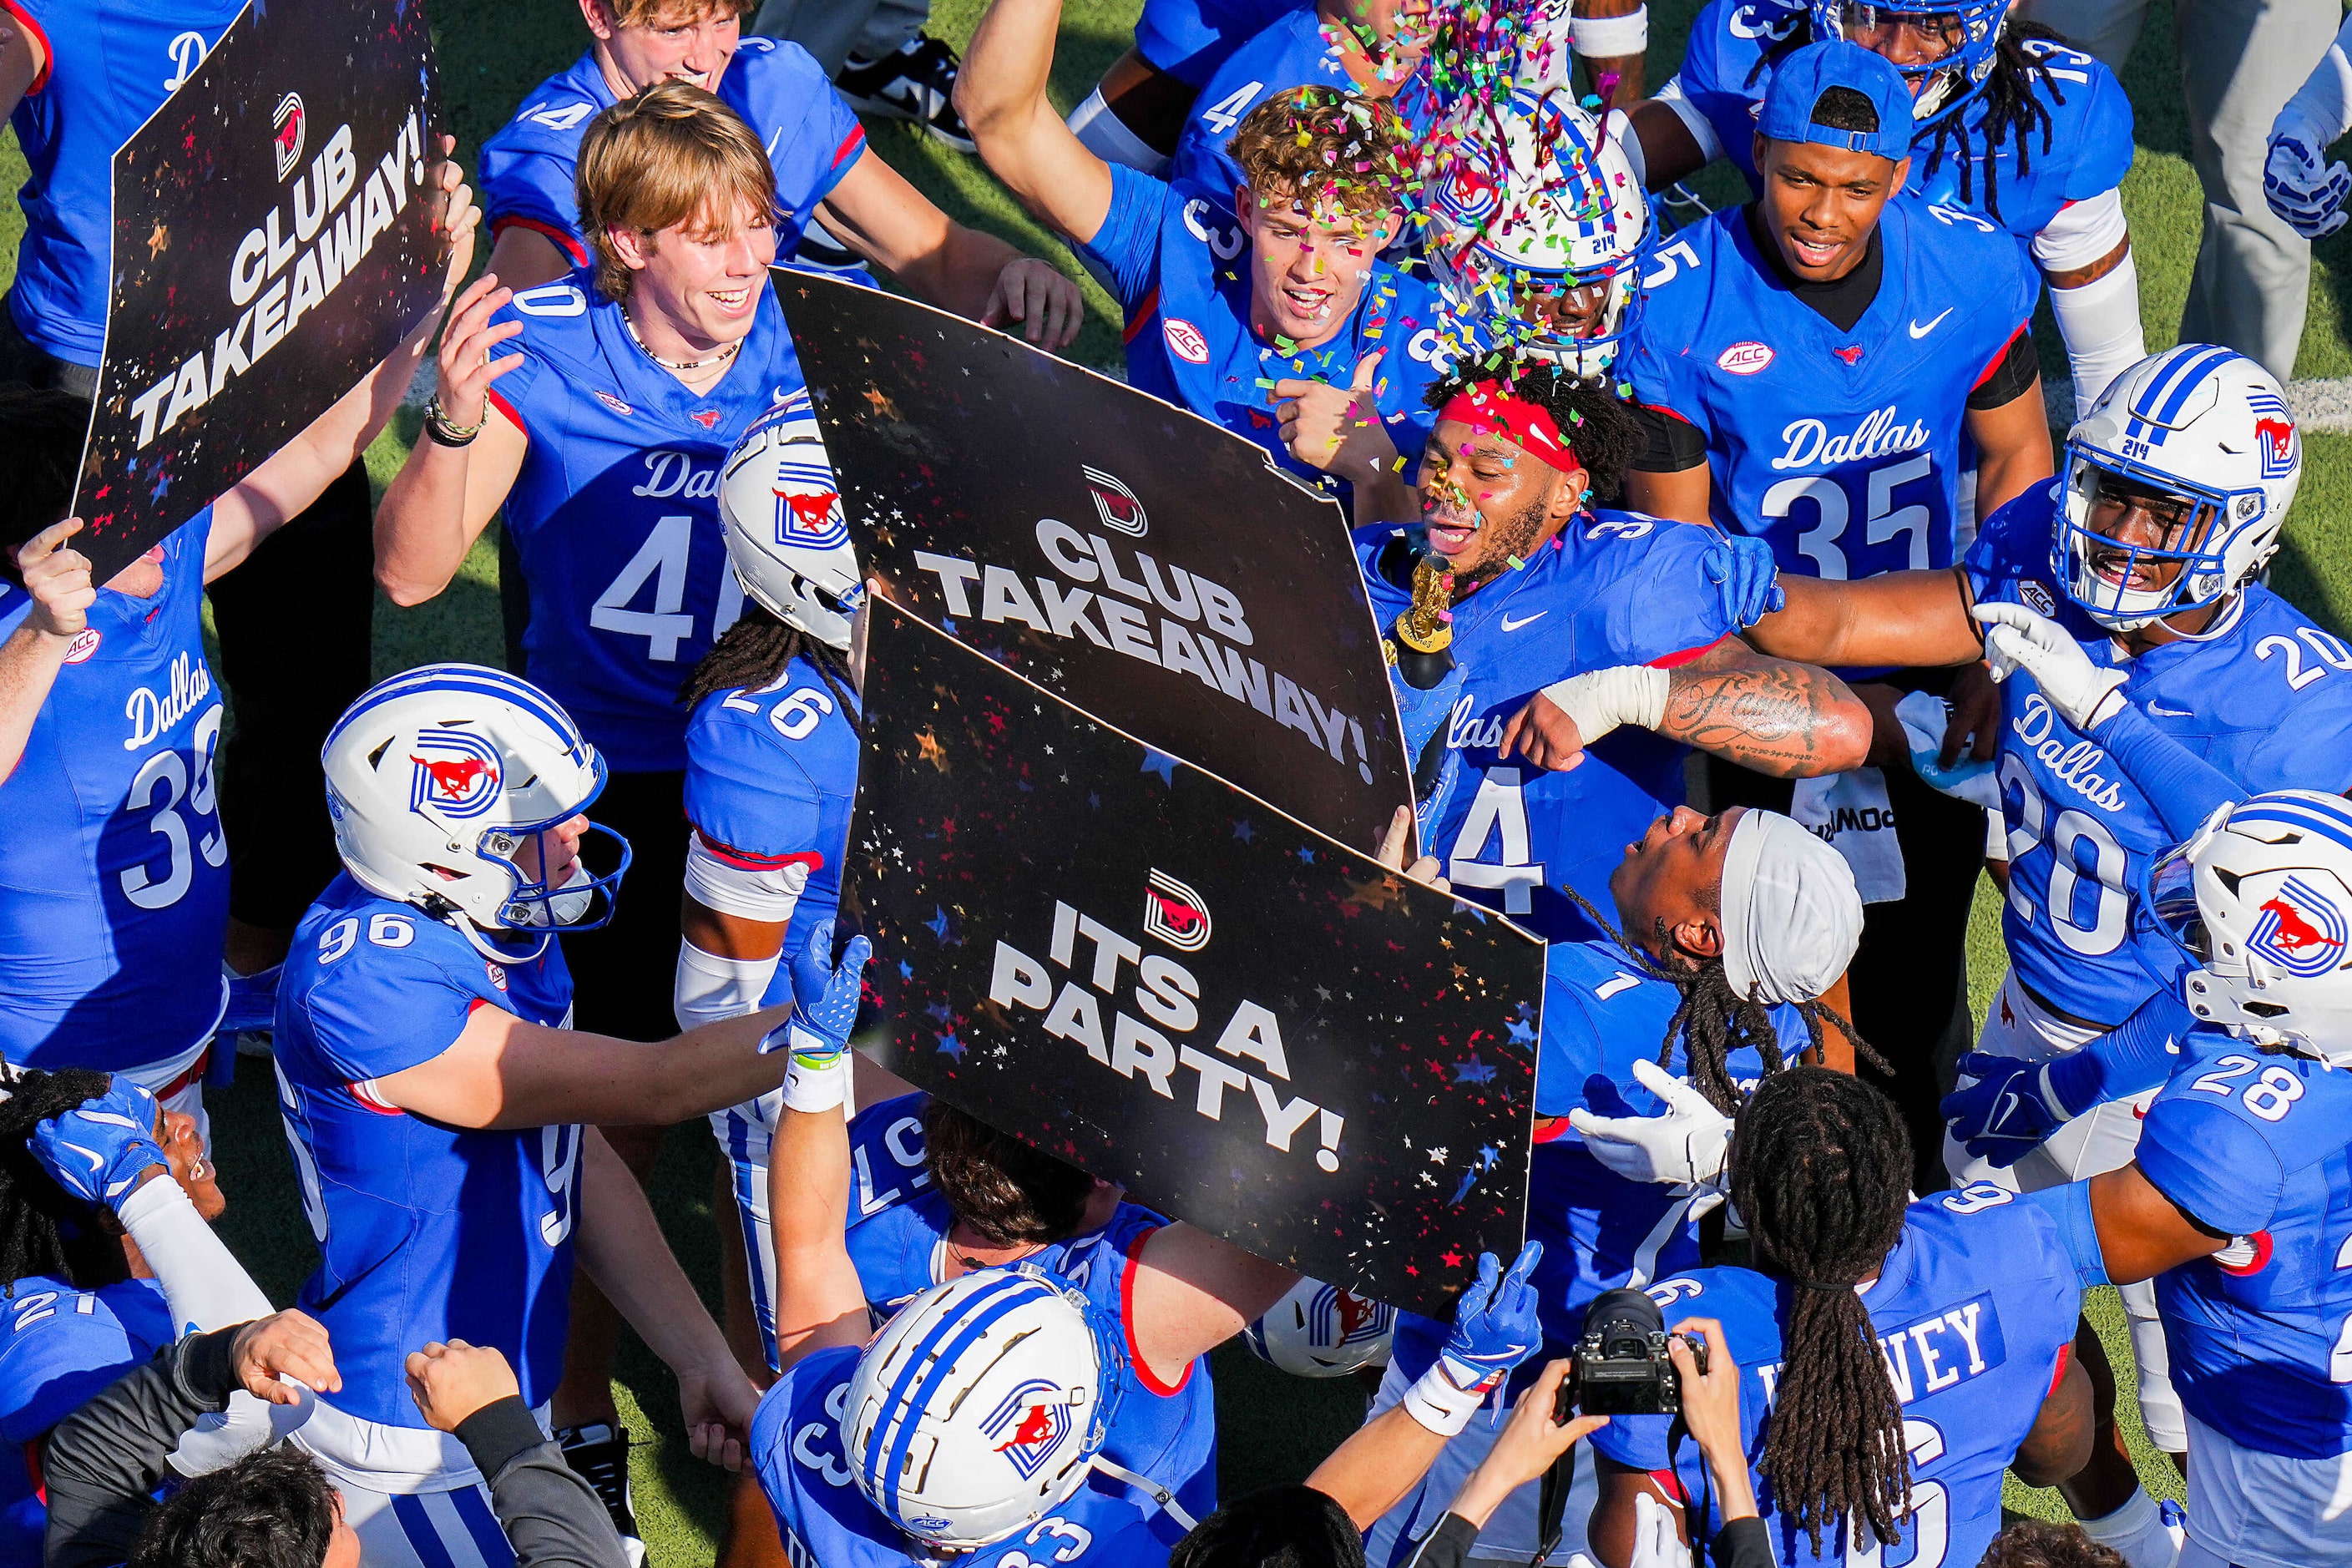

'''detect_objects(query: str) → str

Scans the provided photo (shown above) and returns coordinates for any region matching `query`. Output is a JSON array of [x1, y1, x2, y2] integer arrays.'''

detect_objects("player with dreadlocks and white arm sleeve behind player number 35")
[[1632, 0, 2147, 422]]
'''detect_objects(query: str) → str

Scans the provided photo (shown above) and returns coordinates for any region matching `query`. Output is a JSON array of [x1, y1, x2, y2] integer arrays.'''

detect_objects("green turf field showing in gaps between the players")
[[0, 0, 2352, 1568]]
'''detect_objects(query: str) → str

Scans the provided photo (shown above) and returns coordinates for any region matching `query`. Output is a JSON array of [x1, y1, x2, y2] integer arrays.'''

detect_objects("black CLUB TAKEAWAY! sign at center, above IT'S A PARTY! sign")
[[776, 273, 1411, 860]]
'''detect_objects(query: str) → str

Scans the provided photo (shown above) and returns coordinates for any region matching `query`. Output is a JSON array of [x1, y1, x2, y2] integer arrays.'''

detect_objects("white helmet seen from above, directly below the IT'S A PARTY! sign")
[[842, 1265, 1122, 1549]]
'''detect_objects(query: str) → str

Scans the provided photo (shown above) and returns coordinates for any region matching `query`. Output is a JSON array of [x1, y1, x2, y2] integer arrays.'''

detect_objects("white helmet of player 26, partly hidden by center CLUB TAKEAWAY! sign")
[[720, 392, 866, 651]]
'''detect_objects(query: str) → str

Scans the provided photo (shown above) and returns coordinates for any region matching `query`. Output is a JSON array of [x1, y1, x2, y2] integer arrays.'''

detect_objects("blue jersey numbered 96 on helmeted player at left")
[[276, 874, 581, 1427]]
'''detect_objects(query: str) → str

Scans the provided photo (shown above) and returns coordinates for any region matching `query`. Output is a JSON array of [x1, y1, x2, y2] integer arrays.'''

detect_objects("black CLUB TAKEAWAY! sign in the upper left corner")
[[73, 0, 449, 580]]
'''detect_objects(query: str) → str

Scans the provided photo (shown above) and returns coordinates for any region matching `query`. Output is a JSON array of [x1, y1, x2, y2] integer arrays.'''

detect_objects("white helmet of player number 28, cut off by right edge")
[[2142, 790, 2352, 1067]]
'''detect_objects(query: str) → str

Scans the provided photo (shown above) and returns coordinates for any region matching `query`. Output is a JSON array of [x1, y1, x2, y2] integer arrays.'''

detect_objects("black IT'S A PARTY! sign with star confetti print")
[[842, 604, 1543, 1317]]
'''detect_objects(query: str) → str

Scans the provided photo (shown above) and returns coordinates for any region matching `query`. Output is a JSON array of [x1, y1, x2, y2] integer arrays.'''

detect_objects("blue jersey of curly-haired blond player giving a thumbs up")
[[1082, 164, 1454, 496]]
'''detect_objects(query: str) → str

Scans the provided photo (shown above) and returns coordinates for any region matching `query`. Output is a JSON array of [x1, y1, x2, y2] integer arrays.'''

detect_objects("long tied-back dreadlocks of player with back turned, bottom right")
[[1731, 1067, 1912, 1556]]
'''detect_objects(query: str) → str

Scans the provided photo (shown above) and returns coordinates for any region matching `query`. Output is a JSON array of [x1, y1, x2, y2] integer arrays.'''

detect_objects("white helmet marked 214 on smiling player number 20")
[[2051, 343, 2303, 632]]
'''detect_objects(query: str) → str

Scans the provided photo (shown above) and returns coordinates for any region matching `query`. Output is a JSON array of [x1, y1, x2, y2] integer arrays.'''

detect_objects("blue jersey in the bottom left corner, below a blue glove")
[[0, 1274, 176, 1563]]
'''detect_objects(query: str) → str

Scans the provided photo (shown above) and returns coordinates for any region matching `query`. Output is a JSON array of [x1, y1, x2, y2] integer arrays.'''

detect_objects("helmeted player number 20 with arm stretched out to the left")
[[1702, 343, 2352, 1560]]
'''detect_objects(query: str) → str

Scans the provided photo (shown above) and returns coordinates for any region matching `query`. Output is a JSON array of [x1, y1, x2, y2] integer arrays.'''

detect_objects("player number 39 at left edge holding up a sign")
[[0, 164, 475, 1136]]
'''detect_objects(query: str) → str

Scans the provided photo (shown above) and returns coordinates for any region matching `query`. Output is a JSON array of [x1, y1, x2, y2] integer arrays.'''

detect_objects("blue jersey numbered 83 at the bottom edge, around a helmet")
[[751, 1345, 1183, 1568]]
